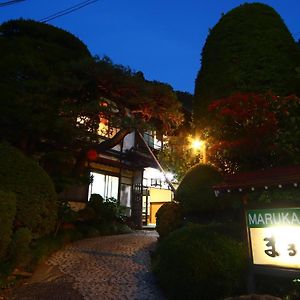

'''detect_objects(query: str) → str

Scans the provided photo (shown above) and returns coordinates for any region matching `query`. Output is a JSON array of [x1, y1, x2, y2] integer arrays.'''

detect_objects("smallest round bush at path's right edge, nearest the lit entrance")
[[156, 202, 183, 237]]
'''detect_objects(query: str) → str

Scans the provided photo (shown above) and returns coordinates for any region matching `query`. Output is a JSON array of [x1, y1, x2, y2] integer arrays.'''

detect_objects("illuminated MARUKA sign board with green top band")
[[246, 207, 300, 269]]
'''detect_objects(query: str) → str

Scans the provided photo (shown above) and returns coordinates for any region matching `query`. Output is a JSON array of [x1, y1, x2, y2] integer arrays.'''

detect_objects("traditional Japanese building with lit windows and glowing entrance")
[[60, 127, 173, 228]]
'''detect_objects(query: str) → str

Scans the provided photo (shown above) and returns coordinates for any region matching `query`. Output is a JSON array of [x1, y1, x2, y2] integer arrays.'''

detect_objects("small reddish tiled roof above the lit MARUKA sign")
[[214, 165, 300, 191]]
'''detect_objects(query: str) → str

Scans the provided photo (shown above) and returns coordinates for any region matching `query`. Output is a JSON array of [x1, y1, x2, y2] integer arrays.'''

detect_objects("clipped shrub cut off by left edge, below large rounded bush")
[[0, 191, 16, 261]]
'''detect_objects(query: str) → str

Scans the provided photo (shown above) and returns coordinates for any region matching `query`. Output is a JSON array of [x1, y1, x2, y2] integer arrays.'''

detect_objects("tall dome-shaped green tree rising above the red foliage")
[[194, 3, 300, 123]]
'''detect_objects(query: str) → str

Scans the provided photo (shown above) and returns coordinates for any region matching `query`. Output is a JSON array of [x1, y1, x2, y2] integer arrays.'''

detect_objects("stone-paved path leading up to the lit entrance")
[[11, 231, 164, 300]]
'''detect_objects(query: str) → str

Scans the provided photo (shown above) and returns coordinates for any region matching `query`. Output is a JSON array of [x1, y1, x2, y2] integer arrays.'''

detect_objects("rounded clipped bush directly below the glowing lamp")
[[175, 164, 222, 215]]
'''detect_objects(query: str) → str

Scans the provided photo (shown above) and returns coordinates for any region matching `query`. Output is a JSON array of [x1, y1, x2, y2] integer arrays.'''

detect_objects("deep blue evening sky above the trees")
[[0, 0, 300, 93]]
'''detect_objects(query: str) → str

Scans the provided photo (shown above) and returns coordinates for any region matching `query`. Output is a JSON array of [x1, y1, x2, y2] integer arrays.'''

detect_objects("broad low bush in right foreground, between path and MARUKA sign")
[[153, 225, 246, 300]]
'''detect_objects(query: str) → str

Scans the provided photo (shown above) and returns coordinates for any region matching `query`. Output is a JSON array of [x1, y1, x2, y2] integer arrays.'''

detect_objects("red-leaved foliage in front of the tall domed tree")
[[208, 93, 300, 171]]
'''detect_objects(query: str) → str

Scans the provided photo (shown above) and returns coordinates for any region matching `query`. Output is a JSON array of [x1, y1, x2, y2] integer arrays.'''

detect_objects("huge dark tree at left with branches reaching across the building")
[[0, 20, 182, 189]]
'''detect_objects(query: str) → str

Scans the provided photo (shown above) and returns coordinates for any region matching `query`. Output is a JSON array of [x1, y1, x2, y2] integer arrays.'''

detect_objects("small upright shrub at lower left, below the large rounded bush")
[[10, 227, 32, 267]]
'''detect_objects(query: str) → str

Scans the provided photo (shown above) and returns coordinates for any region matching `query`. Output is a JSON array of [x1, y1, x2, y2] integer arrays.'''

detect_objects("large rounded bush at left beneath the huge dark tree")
[[0, 143, 57, 238]]
